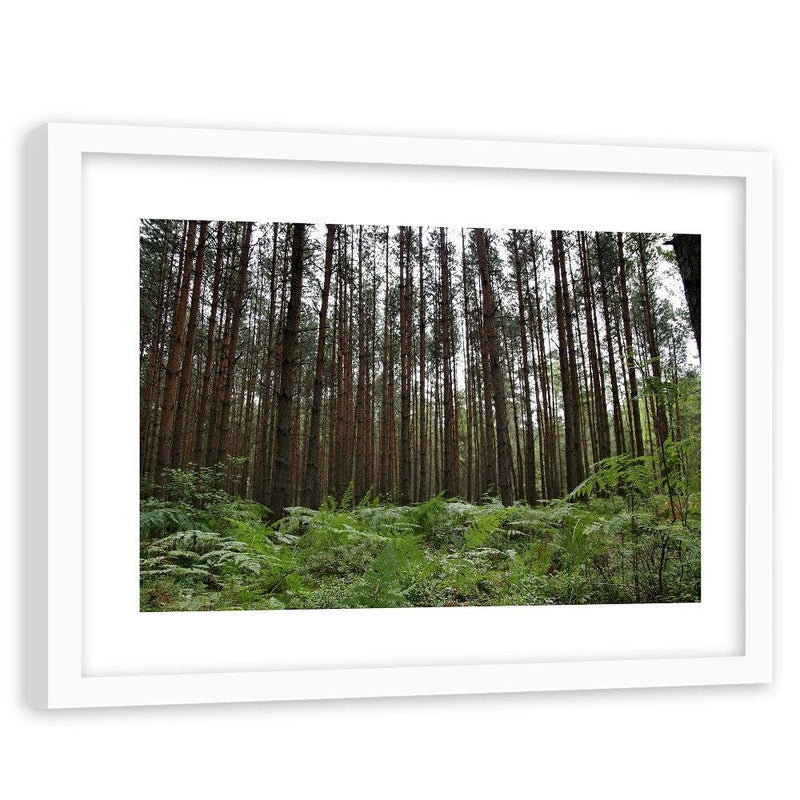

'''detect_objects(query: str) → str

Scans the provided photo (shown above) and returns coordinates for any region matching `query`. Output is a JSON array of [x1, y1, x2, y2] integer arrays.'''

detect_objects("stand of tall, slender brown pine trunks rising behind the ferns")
[[140, 220, 699, 506]]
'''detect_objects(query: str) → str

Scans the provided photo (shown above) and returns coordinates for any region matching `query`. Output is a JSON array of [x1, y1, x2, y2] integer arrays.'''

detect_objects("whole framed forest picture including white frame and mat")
[[27, 124, 772, 708]]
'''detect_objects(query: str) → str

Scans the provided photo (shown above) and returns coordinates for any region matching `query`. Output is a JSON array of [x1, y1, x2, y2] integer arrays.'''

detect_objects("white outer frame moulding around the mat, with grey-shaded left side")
[[26, 123, 772, 708]]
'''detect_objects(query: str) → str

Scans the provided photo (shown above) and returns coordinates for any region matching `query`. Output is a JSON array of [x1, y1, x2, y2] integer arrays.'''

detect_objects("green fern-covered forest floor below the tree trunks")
[[140, 484, 700, 611]]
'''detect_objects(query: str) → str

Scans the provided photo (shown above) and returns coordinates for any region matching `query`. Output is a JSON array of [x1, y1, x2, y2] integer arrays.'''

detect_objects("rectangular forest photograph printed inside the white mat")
[[139, 219, 701, 612]]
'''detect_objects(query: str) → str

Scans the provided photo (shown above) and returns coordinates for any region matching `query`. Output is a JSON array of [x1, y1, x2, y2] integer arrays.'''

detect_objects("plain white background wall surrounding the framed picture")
[[0, 0, 800, 799]]
